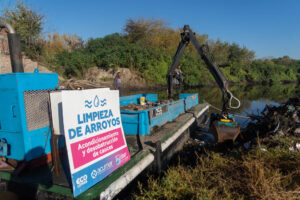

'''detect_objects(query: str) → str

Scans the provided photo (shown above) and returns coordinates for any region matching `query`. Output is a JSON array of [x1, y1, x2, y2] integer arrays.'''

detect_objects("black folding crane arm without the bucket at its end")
[[167, 25, 240, 113]]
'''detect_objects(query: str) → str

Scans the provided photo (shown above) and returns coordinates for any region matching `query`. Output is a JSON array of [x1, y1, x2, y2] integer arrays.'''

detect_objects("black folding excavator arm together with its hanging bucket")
[[167, 25, 240, 142]]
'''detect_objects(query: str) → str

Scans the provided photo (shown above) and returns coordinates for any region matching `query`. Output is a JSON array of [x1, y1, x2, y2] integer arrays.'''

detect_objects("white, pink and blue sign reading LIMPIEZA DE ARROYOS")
[[61, 89, 130, 197]]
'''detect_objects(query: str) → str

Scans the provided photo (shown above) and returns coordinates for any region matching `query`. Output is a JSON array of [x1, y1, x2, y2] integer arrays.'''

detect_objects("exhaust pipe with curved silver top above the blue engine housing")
[[0, 19, 24, 73]]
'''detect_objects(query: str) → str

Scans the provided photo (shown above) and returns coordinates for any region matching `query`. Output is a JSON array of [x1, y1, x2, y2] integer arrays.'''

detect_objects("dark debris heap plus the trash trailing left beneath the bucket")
[[193, 98, 300, 152]]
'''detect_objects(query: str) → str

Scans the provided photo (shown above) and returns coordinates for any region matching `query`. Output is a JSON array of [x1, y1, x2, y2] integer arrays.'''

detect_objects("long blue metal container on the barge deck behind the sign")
[[120, 94, 199, 136]]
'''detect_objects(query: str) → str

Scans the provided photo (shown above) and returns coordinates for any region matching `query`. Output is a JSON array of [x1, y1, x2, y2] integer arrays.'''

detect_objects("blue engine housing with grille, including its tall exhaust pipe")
[[0, 20, 58, 161]]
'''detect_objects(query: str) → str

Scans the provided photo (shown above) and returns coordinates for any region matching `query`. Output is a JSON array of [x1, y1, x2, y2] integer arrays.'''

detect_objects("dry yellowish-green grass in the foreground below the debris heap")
[[134, 138, 300, 200]]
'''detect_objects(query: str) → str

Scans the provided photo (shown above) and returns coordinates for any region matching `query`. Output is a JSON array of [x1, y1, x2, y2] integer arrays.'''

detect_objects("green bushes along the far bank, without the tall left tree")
[[32, 18, 300, 86]]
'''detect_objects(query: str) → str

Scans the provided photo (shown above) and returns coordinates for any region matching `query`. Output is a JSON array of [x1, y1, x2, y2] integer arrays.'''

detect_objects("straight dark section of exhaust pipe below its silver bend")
[[8, 33, 24, 73]]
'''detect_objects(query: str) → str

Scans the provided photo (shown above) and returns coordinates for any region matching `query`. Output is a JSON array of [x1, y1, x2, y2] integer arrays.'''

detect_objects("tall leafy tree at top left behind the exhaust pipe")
[[2, 0, 45, 57]]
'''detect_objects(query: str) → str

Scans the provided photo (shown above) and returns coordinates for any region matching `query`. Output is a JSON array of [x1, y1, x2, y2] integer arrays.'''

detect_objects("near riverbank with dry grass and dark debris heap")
[[134, 98, 300, 200]]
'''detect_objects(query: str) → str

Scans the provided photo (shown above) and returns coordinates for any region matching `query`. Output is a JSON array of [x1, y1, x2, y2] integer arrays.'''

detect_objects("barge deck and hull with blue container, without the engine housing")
[[0, 94, 209, 200]]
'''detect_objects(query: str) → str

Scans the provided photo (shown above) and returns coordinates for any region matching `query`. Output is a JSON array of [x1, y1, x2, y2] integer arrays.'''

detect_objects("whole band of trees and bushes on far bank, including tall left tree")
[[2, 1, 300, 86]]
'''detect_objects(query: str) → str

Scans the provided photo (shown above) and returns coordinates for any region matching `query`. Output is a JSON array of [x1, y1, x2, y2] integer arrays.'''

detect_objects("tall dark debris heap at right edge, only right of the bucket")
[[239, 98, 300, 151]]
